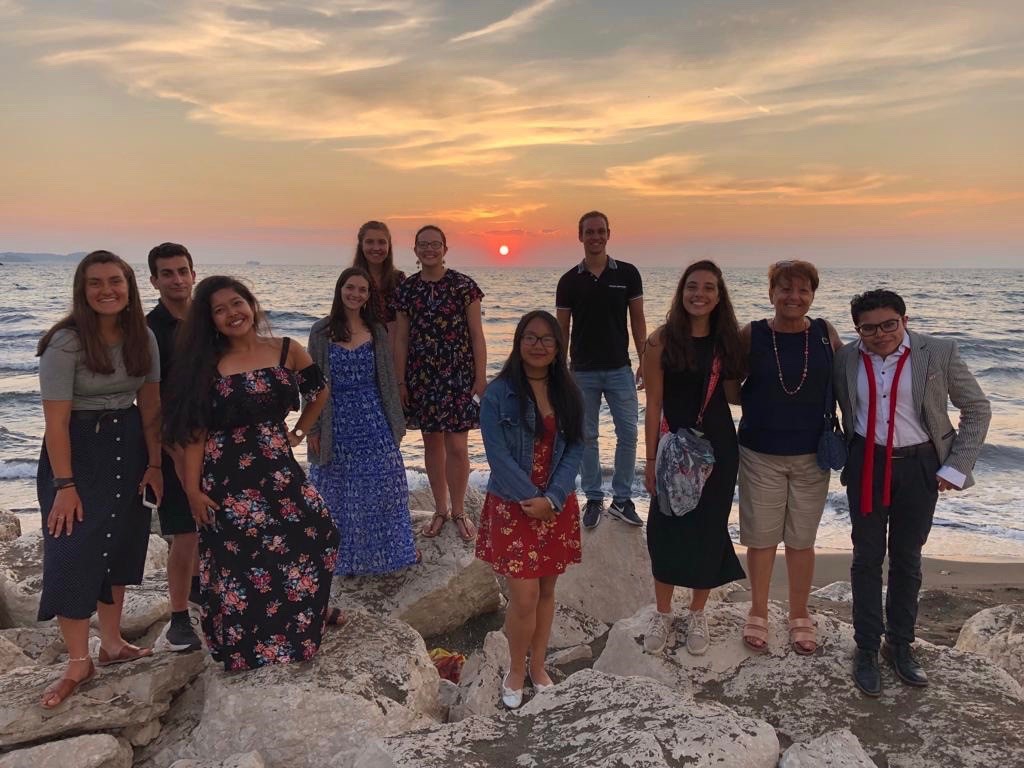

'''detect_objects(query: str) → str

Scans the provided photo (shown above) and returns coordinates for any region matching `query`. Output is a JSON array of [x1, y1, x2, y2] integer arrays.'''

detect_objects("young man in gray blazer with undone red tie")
[[834, 290, 991, 696]]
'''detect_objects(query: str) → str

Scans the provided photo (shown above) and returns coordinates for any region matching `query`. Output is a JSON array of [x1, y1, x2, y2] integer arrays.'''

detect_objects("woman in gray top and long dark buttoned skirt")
[[36, 251, 163, 710]]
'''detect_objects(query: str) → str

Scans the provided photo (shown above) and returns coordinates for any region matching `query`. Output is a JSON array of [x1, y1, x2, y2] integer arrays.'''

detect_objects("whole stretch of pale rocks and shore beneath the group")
[[0, 499, 1024, 768]]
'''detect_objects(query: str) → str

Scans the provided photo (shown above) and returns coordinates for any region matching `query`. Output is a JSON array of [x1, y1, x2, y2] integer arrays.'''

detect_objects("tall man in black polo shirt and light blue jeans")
[[555, 211, 647, 528]]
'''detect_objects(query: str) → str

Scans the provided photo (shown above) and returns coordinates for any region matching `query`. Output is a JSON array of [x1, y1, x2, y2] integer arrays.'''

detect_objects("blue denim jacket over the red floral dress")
[[480, 379, 583, 511]]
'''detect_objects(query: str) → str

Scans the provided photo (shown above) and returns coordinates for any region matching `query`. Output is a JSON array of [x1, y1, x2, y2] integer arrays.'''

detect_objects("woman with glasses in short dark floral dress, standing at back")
[[395, 225, 487, 542]]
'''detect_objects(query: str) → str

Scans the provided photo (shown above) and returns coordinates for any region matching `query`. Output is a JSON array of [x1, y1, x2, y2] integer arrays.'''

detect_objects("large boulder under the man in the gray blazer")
[[594, 603, 1024, 768]]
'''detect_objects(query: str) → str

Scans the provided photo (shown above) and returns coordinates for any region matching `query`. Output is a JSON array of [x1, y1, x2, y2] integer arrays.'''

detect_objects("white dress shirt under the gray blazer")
[[854, 331, 967, 488]]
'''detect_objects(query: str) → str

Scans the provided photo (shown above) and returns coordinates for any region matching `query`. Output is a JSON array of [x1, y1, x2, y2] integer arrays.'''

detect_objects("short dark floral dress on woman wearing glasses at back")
[[396, 269, 483, 432]]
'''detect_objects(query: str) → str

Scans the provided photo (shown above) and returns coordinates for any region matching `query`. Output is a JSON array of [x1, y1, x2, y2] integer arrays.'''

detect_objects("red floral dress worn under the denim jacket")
[[476, 415, 582, 579]]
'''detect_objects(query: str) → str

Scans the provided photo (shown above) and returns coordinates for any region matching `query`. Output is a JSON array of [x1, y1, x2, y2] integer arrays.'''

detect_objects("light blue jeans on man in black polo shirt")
[[573, 366, 640, 502]]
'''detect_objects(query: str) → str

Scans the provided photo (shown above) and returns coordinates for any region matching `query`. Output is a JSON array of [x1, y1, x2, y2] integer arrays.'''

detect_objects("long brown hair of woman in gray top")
[[36, 251, 153, 376]]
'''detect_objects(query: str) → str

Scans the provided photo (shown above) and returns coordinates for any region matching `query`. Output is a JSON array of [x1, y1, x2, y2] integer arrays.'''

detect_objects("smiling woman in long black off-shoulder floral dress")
[[166, 275, 338, 670]]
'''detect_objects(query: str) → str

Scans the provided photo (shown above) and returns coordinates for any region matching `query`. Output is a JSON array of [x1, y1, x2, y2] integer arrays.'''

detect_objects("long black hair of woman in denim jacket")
[[497, 309, 583, 442]]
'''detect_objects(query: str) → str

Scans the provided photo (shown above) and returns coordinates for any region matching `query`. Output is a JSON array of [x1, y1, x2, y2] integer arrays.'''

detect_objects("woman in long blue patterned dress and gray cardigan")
[[309, 267, 417, 575]]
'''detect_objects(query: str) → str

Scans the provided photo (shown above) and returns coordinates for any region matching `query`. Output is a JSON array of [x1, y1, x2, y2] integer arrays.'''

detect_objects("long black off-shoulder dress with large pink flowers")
[[200, 348, 338, 670]]
